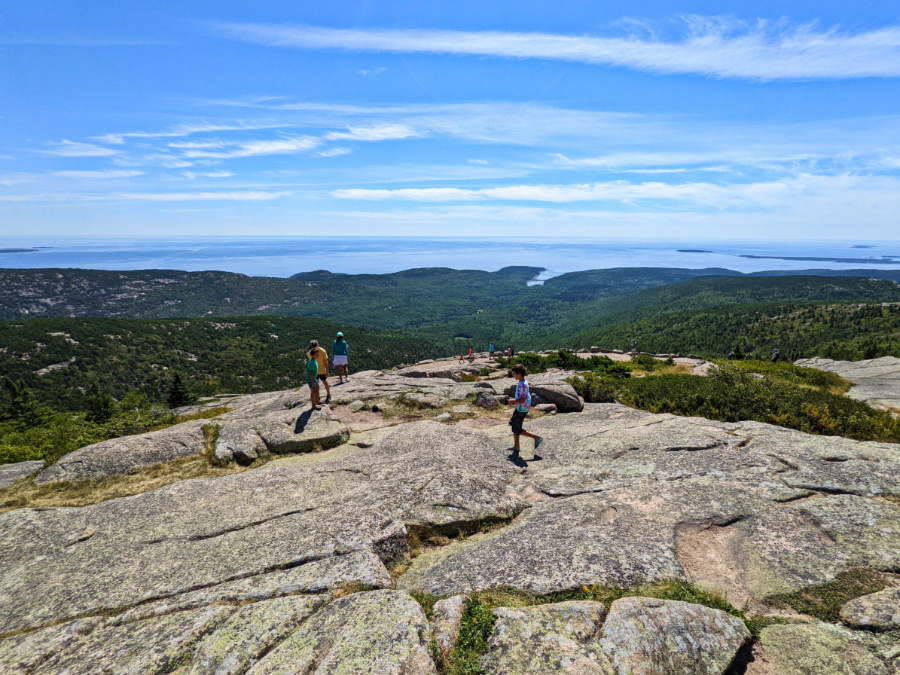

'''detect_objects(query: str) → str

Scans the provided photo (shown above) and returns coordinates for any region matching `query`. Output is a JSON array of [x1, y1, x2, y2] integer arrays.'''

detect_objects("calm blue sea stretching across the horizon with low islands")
[[0, 237, 900, 279]]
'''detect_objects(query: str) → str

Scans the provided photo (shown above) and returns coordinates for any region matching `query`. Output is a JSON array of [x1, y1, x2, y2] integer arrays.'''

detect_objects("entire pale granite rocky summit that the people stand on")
[[0, 358, 900, 675]]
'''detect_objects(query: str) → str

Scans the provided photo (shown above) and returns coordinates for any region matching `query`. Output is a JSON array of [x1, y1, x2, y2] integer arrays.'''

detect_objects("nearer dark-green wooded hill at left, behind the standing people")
[[0, 316, 445, 410]]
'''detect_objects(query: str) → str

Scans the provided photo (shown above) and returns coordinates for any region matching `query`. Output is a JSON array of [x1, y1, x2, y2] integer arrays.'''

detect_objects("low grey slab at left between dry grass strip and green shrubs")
[[35, 420, 209, 483]]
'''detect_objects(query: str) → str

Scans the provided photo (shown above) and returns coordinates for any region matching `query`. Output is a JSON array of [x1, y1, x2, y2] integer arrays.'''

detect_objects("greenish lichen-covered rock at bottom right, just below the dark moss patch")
[[759, 623, 896, 675]]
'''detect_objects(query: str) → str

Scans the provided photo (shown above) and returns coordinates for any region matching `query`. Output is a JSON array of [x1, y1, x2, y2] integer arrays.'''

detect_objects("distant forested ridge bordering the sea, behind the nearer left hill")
[[0, 267, 734, 327]]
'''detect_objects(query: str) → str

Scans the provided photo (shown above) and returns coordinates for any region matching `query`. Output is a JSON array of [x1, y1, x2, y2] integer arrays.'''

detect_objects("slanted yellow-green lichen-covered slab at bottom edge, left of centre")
[[187, 596, 322, 675]]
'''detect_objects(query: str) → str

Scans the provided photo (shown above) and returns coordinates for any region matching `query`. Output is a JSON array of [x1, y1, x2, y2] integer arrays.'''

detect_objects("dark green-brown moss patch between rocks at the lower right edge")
[[766, 569, 893, 621]]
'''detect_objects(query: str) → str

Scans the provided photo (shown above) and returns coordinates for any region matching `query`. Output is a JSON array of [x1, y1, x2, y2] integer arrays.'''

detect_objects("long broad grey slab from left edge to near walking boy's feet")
[[0, 422, 524, 632]]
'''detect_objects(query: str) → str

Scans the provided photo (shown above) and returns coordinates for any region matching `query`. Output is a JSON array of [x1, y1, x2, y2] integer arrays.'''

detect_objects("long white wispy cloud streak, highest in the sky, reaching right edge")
[[214, 17, 900, 80]]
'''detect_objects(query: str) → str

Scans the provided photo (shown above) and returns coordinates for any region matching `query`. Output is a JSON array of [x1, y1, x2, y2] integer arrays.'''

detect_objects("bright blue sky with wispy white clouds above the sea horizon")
[[0, 0, 900, 241]]
